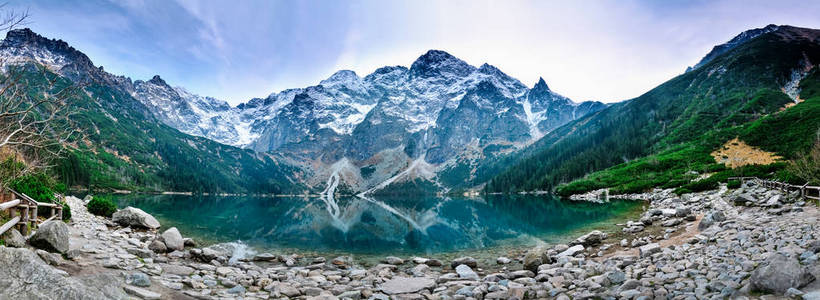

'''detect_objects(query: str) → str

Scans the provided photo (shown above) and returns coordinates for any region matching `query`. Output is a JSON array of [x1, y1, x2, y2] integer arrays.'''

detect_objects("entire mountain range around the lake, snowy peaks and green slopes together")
[[0, 25, 819, 193]]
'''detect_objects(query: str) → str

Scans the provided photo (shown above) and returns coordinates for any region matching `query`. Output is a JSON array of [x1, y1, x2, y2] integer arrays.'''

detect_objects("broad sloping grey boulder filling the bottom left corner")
[[0, 246, 125, 299]]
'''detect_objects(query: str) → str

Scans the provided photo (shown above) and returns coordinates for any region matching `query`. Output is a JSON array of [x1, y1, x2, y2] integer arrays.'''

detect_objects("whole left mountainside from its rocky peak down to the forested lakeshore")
[[0, 29, 301, 193]]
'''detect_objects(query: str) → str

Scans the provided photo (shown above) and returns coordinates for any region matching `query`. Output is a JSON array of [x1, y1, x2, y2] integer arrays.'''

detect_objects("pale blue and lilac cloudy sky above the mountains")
[[8, 0, 820, 105]]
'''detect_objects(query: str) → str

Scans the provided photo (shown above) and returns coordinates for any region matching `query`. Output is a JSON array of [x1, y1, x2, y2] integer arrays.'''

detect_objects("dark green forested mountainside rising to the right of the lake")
[[486, 26, 820, 195]]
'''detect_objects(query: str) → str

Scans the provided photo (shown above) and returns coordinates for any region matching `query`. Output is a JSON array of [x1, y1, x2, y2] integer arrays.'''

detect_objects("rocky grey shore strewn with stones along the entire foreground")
[[0, 183, 820, 299]]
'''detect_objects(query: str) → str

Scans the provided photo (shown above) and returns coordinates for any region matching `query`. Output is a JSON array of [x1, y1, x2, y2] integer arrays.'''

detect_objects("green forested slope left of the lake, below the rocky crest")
[[12, 64, 301, 193]]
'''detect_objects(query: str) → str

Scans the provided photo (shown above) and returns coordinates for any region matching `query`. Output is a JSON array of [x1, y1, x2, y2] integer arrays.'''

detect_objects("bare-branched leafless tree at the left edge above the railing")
[[0, 4, 82, 180]]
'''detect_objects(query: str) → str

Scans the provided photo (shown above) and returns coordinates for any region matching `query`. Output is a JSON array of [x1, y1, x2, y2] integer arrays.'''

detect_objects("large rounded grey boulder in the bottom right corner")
[[750, 253, 815, 295]]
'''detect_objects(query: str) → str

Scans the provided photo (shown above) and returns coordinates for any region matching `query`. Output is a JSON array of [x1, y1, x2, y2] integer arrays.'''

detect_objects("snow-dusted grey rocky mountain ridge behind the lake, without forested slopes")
[[0, 29, 606, 189]]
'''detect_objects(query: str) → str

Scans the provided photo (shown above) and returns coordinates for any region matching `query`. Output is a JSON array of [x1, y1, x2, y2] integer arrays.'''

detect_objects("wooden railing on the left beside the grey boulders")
[[0, 189, 63, 235]]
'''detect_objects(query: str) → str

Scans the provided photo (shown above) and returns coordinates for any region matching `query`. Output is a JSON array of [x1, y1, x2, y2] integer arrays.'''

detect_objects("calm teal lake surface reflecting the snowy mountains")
[[112, 195, 643, 255]]
